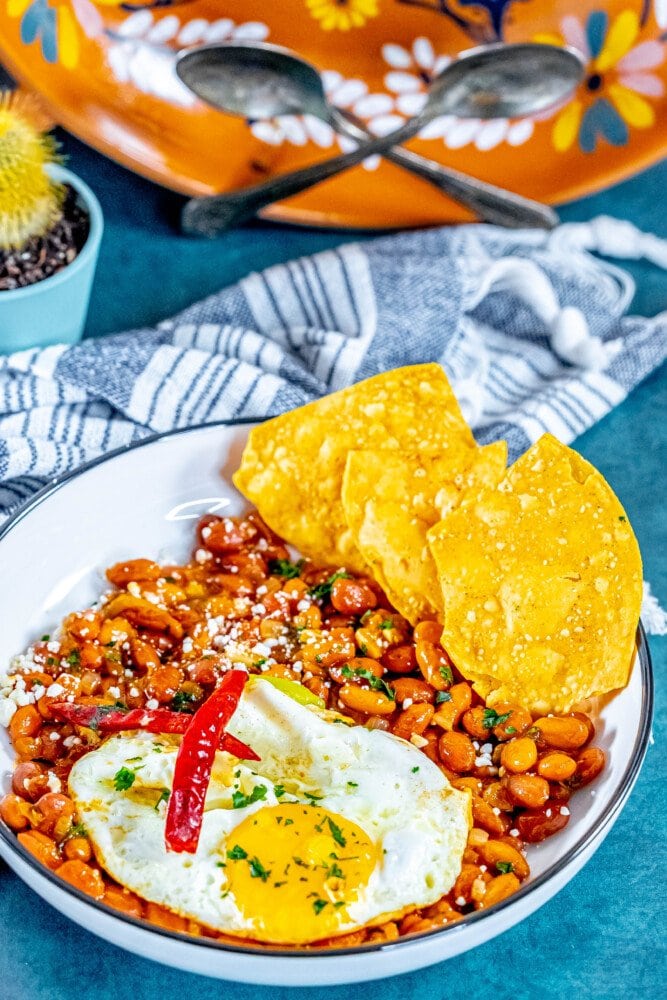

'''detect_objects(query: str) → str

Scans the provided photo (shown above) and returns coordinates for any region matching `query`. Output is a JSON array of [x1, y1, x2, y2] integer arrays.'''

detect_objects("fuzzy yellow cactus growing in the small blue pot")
[[0, 92, 65, 250]]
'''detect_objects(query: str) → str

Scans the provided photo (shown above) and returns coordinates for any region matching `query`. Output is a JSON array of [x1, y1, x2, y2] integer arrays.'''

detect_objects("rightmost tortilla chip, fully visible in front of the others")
[[428, 434, 642, 712]]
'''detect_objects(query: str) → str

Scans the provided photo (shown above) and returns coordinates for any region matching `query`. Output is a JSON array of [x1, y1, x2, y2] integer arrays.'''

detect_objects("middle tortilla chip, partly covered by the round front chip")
[[342, 441, 507, 625]]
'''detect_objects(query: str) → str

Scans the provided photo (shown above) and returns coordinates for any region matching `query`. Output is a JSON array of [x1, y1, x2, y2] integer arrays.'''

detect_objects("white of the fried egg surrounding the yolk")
[[69, 678, 471, 943]]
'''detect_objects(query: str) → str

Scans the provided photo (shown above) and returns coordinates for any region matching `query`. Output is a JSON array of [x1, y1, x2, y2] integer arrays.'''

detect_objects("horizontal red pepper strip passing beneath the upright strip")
[[50, 701, 260, 760]]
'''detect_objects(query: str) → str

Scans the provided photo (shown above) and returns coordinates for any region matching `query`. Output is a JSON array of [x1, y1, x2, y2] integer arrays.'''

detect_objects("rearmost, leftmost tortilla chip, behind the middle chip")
[[234, 364, 476, 573]]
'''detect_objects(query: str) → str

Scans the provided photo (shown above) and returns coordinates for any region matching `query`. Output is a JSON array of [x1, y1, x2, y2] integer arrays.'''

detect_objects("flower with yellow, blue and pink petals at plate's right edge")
[[536, 10, 664, 153]]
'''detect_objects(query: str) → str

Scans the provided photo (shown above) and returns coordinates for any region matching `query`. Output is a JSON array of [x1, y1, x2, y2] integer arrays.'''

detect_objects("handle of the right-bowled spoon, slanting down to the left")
[[181, 115, 428, 236]]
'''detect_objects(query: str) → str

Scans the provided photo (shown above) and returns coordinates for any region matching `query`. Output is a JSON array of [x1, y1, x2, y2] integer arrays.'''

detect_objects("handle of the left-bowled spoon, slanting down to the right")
[[331, 107, 559, 229]]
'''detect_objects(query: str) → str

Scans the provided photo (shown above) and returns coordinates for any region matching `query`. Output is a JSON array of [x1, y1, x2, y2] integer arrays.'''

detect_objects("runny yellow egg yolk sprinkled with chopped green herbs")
[[223, 802, 379, 944]]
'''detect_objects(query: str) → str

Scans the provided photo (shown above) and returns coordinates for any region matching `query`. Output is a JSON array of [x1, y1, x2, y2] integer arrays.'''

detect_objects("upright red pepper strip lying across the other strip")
[[164, 670, 248, 854]]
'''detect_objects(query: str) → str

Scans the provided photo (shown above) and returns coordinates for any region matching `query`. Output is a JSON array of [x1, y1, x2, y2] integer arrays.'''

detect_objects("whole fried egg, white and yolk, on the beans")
[[69, 678, 471, 944]]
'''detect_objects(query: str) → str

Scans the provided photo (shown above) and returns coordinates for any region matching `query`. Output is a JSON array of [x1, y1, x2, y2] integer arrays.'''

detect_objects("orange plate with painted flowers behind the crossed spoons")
[[0, 0, 667, 227]]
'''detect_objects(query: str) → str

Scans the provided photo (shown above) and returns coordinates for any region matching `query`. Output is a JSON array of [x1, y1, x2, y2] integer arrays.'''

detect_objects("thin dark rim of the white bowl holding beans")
[[0, 417, 654, 959]]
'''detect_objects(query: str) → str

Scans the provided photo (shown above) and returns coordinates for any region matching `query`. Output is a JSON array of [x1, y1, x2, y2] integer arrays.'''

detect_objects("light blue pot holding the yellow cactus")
[[0, 165, 104, 354]]
